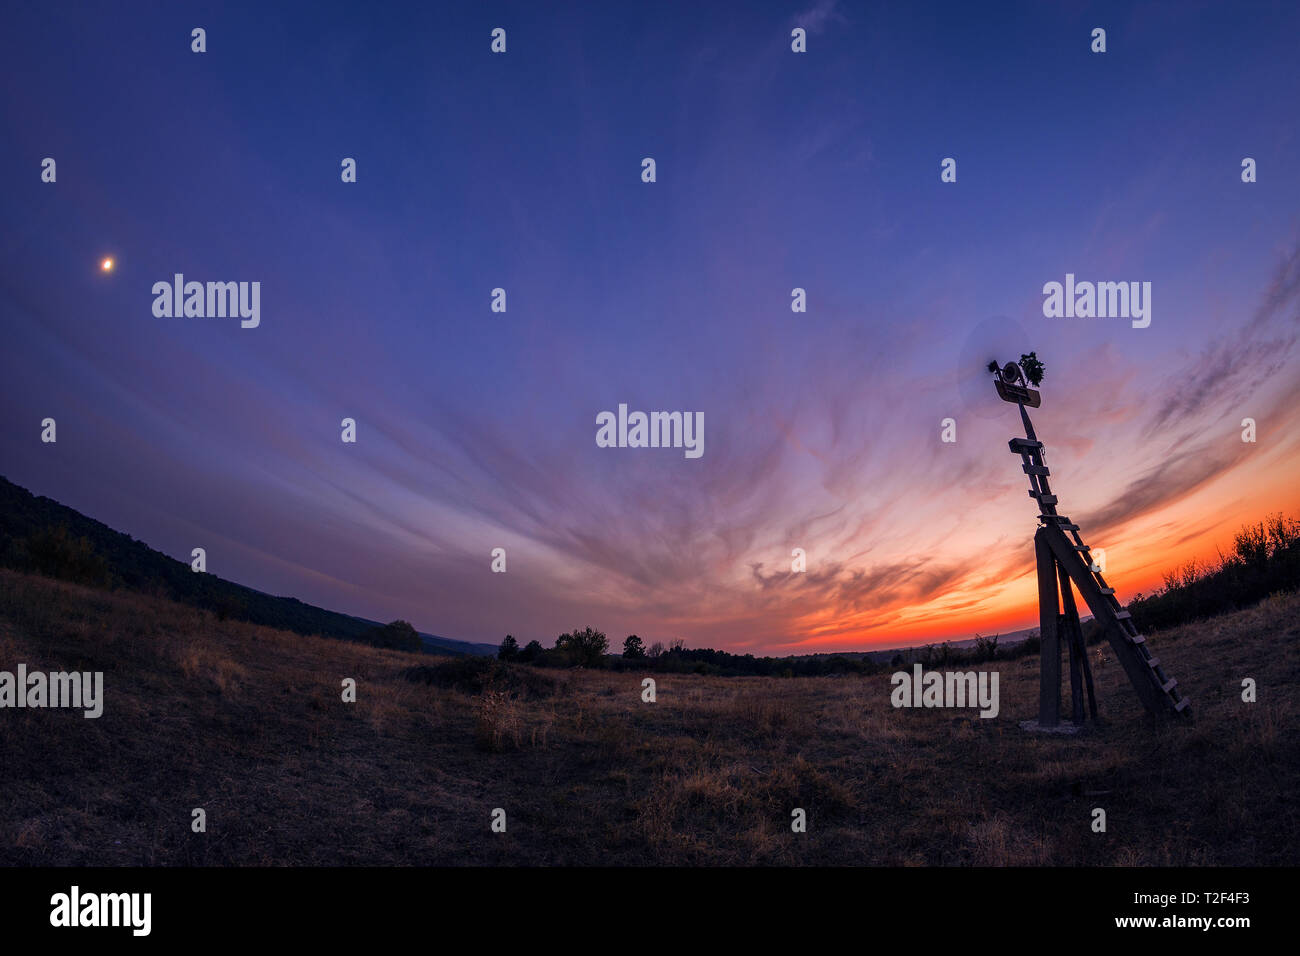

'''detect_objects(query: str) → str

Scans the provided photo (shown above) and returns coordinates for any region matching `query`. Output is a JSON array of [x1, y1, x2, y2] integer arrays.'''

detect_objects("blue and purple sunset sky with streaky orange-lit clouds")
[[0, 0, 1300, 654]]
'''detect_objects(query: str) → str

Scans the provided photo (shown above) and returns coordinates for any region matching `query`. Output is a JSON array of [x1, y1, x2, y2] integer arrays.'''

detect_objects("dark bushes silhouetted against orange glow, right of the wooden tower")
[[1128, 514, 1300, 631]]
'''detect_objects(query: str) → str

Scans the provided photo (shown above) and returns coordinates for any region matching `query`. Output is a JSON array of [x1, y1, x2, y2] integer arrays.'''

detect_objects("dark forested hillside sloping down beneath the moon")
[[0, 477, 424, 650]]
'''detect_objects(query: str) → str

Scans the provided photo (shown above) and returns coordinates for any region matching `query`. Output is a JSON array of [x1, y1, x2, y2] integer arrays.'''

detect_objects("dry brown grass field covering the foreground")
[[0, 571, 1300, 866]]
